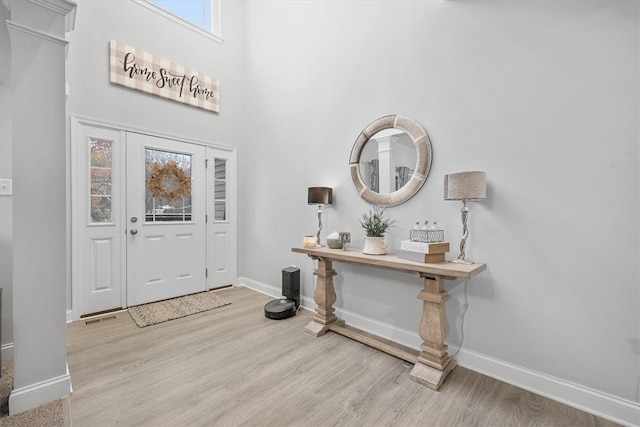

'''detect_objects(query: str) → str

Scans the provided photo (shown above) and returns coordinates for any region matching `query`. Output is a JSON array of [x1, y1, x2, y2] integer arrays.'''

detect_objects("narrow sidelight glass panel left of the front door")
[[89, 138, 113, 222]]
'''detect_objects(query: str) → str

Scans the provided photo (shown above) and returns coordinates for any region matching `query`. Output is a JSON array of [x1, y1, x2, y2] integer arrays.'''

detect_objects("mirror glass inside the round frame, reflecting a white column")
[[360, 129, 418, 193]]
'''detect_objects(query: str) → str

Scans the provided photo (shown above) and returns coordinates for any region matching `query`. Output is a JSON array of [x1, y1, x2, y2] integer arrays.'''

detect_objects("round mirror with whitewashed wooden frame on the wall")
[[349, 115, 432, 206]]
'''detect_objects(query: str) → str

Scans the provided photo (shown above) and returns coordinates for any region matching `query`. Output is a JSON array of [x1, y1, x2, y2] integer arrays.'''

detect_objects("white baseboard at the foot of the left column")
[[9, 365, 71, 415]]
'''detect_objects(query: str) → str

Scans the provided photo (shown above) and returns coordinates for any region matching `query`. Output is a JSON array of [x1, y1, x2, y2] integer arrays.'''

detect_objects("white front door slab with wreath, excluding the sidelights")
[[126, 132, 206, 306]]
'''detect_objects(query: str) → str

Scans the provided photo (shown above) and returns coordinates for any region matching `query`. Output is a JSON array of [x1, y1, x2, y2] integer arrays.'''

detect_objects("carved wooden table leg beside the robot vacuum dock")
[[305, 258, 338, 337]]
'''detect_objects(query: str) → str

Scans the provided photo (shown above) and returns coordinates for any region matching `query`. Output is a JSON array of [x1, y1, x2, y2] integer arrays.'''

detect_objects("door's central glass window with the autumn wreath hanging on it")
[[145, 148, 192, 222]]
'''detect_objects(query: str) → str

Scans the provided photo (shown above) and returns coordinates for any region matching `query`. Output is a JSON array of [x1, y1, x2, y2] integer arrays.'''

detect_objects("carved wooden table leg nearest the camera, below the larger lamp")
[[410, 276, 456, 390]]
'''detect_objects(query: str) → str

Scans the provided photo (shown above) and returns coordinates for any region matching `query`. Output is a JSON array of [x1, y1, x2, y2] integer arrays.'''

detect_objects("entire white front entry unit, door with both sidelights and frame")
[[73, 118, 236, 321]]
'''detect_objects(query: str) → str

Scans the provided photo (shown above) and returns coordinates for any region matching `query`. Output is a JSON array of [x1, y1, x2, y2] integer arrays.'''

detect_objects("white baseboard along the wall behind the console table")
[[237, 277, 640, 426]]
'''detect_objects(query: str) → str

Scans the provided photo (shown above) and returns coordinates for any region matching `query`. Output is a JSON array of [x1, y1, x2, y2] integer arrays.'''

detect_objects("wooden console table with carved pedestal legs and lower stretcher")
[[291, 247, 486, 390]]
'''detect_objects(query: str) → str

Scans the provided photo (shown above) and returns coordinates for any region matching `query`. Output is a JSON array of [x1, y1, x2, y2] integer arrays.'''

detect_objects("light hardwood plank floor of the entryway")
[[67, 287, 615, 427]]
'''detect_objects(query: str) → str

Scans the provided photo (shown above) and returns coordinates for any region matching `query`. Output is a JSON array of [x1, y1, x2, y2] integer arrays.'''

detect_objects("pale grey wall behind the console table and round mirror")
[[239, 0, 640, 422]]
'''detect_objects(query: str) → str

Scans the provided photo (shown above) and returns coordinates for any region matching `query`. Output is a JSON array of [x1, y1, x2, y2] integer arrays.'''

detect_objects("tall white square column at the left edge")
[[7, 0, 75, 414]]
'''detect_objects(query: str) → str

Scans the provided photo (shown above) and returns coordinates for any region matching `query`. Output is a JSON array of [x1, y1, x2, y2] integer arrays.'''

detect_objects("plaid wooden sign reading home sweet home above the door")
[[109, 40, 220, 113]]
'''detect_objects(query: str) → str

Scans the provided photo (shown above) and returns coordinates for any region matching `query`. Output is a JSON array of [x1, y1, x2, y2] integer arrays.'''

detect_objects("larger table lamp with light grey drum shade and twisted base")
[[444, 171, 487, 264]]
